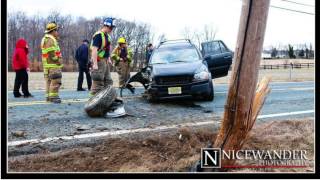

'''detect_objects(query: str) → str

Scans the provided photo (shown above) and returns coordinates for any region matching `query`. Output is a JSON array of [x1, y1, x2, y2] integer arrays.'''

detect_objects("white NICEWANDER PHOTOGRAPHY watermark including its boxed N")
[[201, 148, 308, 168]]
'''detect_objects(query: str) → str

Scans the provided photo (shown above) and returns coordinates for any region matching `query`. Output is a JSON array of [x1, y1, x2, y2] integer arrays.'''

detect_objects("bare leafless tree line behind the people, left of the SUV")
[[8, 11, 154, 71]]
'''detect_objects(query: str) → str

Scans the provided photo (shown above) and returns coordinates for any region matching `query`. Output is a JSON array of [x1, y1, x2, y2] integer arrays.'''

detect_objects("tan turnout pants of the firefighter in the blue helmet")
[[90, 59, 113, 96]]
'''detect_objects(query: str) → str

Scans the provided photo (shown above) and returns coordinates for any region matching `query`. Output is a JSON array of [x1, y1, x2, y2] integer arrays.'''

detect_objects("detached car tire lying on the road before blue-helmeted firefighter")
[[84, 86, 117, 117]]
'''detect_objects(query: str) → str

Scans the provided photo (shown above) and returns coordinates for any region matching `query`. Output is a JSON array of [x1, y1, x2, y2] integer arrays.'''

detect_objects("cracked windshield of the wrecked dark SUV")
[[151, 48, 200, 64]]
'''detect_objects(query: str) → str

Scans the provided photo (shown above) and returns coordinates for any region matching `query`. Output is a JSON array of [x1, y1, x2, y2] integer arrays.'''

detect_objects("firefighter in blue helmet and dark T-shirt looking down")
[[89, 17, 115, 96]]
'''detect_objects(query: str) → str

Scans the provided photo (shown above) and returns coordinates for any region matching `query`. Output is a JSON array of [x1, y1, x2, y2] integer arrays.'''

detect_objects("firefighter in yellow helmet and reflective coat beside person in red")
[[41, 22, 63, 103]]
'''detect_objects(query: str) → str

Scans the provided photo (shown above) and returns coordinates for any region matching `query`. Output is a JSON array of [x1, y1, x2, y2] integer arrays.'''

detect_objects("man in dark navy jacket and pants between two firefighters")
[[75, 39, 92, 91]]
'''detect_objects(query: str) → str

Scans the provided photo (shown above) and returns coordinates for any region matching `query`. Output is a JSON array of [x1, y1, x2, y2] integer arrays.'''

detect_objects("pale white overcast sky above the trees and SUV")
[[7, 0, 315, 49]]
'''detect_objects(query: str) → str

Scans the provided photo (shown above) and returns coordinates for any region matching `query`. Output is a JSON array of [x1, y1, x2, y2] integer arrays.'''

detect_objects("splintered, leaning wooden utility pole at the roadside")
[[213, 0, 270, 167]]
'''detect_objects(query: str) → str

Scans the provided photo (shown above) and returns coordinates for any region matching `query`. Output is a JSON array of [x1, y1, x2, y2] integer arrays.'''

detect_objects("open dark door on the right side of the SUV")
[[201, 40, 233, 79]]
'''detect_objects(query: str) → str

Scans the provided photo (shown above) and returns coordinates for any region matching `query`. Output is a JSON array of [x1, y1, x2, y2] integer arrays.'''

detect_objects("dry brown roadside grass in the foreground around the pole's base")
[[9, 119, 314, 172]]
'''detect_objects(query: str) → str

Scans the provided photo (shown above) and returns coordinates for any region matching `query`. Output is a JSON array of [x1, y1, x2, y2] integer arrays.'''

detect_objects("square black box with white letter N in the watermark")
[[201, 148, 221, 168]]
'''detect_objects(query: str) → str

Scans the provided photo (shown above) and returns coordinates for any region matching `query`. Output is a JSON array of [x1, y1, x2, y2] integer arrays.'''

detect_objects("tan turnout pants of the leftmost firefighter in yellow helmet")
[[44, 68, 62, 101]]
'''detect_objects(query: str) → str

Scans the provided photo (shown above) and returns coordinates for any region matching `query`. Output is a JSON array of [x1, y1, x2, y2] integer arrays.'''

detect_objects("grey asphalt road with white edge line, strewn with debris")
[[8, 81, 315, 155]]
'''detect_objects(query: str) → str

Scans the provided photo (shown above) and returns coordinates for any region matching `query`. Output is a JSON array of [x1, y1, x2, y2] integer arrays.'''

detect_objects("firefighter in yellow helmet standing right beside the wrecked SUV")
[[111, 37, 134, 93]]
